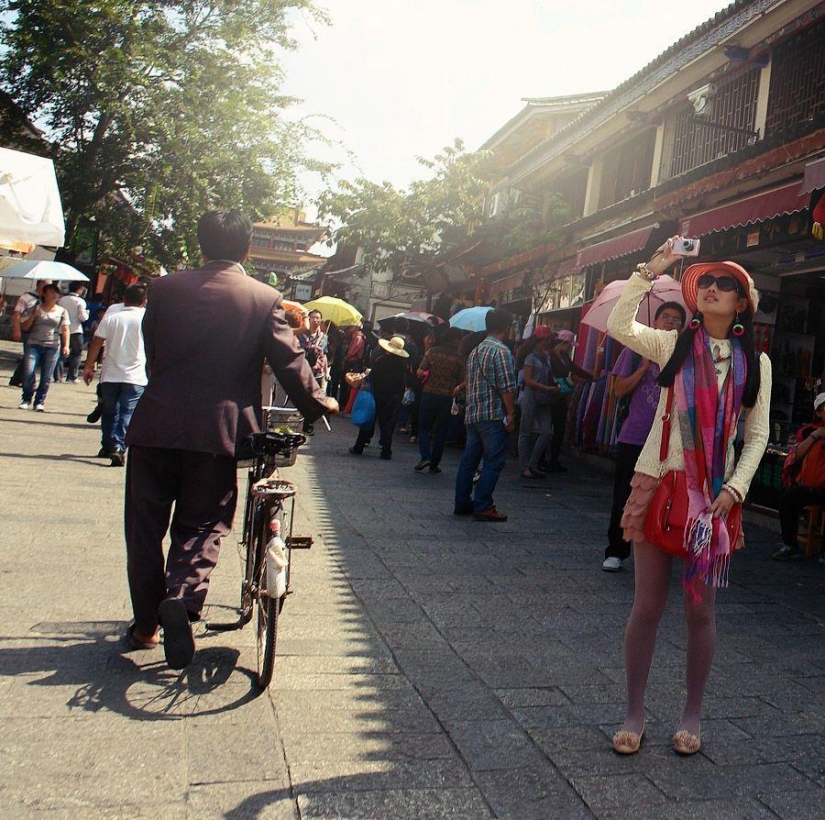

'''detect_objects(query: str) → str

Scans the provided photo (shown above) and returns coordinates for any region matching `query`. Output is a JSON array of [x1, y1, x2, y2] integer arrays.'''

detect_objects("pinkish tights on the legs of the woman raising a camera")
[[623, 541, 716, 734]]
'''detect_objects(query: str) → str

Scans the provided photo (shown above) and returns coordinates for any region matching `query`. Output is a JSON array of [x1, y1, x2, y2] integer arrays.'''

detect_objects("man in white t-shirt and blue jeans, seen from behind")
[[83, 285, 148, 467]]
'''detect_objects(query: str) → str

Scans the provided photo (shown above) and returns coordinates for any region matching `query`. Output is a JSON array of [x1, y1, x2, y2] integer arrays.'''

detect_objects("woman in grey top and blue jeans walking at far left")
[[20, 285, 70, 413]]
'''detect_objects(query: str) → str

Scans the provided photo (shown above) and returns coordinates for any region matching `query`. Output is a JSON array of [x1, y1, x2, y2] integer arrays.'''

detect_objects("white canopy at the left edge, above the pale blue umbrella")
[[0, 148, 66, 247]]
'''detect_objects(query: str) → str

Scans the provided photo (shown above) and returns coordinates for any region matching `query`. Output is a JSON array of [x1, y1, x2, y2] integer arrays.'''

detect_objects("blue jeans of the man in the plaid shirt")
[[455, 419, 508, 512]]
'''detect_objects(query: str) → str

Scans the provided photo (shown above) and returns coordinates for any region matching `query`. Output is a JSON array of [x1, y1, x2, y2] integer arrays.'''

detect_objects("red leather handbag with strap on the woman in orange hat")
[[645, 388, 742, 558]]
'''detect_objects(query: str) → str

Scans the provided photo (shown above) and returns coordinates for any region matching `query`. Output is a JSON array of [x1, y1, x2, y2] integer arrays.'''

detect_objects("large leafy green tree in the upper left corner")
[[0, 0, 324, 265]]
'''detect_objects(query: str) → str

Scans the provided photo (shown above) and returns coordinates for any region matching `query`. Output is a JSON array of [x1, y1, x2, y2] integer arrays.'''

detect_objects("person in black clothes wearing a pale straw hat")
[[349, 336, 410, 461]]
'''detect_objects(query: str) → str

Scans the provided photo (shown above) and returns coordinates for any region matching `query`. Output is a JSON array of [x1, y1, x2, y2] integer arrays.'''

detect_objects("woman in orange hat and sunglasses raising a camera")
[[608, 240, 771, 755]]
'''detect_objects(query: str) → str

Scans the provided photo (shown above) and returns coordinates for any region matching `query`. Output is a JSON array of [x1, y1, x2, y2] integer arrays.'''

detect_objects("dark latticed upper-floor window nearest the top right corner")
[[765, 19, 825, 134]]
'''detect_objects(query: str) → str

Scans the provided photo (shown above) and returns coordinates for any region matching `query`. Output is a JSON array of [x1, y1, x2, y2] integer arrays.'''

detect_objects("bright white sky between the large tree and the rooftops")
[[284, 0, 726, 194]]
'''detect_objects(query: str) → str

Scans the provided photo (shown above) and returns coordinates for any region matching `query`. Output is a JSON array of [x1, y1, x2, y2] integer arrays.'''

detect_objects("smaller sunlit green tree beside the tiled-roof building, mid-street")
[[318, 139, 487, 275]]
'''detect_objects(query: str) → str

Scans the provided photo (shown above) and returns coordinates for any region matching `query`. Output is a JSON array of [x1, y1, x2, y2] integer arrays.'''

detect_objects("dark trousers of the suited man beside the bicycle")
[[125, 446, 238, 635]]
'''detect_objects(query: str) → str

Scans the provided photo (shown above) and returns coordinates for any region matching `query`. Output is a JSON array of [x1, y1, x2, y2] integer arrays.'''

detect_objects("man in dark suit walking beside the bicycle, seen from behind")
[[125, 211, 338, 669]]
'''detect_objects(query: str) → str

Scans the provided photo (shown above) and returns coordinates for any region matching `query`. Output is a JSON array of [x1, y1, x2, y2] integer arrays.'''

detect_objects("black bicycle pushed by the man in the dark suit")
[[207, 431, 313, 689]]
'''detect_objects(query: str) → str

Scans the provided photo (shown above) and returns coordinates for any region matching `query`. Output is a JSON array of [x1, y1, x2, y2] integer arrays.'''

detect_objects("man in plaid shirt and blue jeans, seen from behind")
[[453, 308, 516, 521]]
